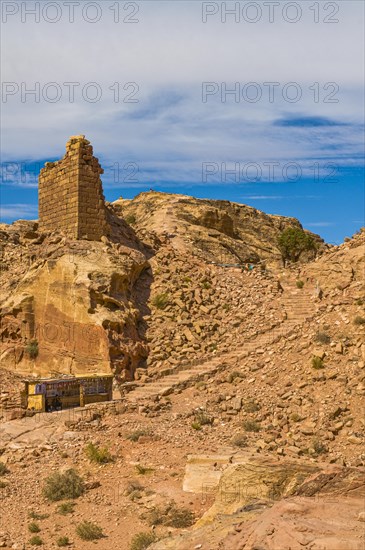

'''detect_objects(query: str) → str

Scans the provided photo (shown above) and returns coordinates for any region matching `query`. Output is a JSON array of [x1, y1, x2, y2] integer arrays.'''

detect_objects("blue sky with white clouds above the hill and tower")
[[1, 0, 364, 243]]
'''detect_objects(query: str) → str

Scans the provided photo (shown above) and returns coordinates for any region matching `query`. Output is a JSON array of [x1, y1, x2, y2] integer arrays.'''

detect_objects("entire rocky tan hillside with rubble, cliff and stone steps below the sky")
[[0, 192, 365, 550]]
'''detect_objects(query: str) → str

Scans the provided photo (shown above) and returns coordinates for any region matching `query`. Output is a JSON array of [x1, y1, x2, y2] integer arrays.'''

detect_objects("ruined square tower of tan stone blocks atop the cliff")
[[39, 136, 108, 241]]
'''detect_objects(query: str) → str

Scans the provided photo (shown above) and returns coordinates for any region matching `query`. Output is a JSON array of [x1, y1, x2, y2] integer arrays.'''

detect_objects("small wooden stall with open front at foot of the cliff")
[[23, 374, 114, 412]]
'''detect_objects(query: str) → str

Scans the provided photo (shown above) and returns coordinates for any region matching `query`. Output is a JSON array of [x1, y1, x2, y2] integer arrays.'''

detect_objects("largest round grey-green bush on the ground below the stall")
[[43, 468, 85, 502]]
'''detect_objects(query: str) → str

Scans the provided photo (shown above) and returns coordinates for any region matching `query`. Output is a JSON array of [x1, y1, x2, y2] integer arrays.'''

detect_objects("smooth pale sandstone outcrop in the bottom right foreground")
[[151, 454, 365, 550]]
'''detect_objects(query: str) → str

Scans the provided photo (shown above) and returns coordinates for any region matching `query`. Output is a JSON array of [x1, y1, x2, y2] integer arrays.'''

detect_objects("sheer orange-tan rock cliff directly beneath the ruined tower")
[[1, 217, 149, 380]]
